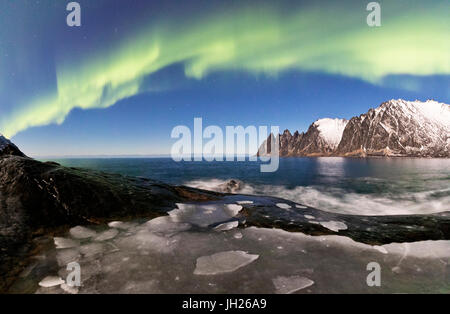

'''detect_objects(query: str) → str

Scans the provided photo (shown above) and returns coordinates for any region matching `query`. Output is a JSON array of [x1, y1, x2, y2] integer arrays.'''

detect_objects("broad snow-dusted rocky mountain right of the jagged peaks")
[[336, 99, 450, 157]]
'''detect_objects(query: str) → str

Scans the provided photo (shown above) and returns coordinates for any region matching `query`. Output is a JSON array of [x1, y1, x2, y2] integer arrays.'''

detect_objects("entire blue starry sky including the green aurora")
[[0, 0, 450, 156]]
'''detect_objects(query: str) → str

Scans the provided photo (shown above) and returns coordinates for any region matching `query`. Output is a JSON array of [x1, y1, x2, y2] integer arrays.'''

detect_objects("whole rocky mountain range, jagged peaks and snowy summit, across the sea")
[[258, 99, 450, 157]]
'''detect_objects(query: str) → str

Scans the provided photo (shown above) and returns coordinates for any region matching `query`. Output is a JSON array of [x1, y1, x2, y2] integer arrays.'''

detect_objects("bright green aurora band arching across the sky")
[[0, 2, 450, 137]]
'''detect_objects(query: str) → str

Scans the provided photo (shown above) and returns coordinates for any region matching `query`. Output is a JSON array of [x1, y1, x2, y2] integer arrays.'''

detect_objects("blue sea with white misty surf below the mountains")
[[43, 158, 450, 215]]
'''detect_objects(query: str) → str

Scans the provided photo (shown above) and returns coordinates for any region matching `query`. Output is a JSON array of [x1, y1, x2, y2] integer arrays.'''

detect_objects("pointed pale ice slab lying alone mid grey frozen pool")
[[194, 251, 259, 275]]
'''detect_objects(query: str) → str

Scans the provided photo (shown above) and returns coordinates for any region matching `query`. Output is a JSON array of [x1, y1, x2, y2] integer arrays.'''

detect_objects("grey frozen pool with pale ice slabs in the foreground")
[[16, 204, 450, 293]]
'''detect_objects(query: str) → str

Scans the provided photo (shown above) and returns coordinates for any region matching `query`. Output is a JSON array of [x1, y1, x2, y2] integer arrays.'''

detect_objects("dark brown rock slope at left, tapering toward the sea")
[[0, 155, 219, 291]]
